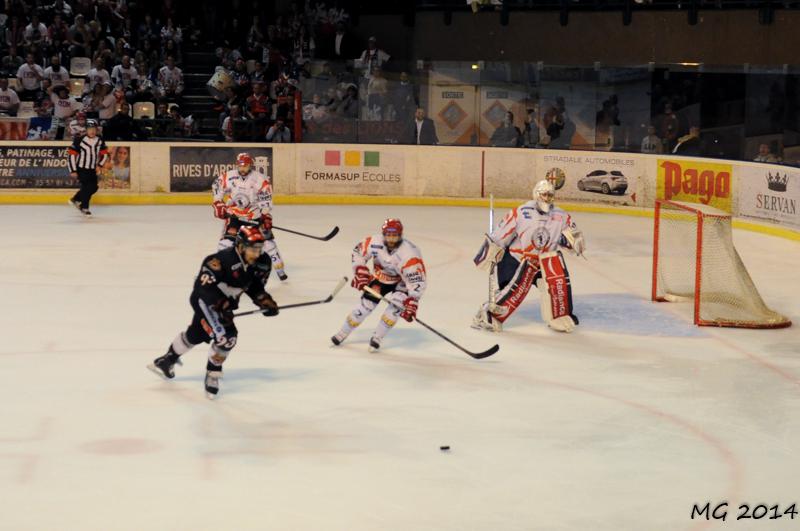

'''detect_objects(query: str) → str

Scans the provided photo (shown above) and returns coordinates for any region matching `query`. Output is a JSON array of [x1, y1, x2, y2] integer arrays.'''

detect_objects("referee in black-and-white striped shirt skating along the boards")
[[67, 120, 108, 217]]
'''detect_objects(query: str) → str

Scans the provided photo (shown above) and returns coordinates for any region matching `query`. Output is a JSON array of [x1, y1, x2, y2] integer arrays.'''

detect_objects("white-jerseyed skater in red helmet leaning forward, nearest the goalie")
[[331, 218, 426, 352]]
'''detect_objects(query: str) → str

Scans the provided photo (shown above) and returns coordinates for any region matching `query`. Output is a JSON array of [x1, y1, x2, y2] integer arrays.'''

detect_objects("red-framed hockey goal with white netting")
[[652, 199, 792, 328]]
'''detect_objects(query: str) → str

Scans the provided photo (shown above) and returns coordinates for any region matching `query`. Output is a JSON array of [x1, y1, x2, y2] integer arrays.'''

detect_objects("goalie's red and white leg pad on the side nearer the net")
[[538, 251, 578, 332]]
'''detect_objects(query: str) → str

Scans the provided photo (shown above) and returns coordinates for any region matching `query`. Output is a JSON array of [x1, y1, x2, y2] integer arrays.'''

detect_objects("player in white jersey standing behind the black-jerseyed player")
[[212, 153, 289, 280]]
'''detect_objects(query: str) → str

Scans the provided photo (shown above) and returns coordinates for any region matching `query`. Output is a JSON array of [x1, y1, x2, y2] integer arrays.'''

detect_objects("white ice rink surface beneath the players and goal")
[[0, 205, 800, 531]]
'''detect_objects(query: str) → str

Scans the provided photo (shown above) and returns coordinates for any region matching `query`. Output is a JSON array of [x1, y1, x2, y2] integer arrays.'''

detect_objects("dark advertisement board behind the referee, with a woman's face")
[[0, 143, 131, 189]]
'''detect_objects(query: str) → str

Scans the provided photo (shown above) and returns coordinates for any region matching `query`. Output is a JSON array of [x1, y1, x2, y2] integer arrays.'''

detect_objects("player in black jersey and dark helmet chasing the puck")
[[148, 226, 278, 399]]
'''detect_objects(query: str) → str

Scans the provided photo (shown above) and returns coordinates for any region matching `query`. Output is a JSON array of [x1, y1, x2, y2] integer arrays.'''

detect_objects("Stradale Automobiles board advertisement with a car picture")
[[536, 151, 647, 206]]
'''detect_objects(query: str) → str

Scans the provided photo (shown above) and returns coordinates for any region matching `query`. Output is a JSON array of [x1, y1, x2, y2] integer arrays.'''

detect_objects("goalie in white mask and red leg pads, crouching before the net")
[[472, 181, 586, 332]]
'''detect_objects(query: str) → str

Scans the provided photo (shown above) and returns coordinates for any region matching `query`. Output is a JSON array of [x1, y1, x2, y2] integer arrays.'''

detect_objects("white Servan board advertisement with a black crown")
[[735, 166, 800, 228]]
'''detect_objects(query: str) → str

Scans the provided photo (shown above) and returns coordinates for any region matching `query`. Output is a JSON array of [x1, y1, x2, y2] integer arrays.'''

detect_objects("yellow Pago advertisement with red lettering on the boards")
[[656, 158, 733, 212]]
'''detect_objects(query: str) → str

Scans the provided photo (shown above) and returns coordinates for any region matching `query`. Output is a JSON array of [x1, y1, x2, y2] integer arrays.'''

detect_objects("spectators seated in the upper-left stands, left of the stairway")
[[0, 0, 194, 140]]
